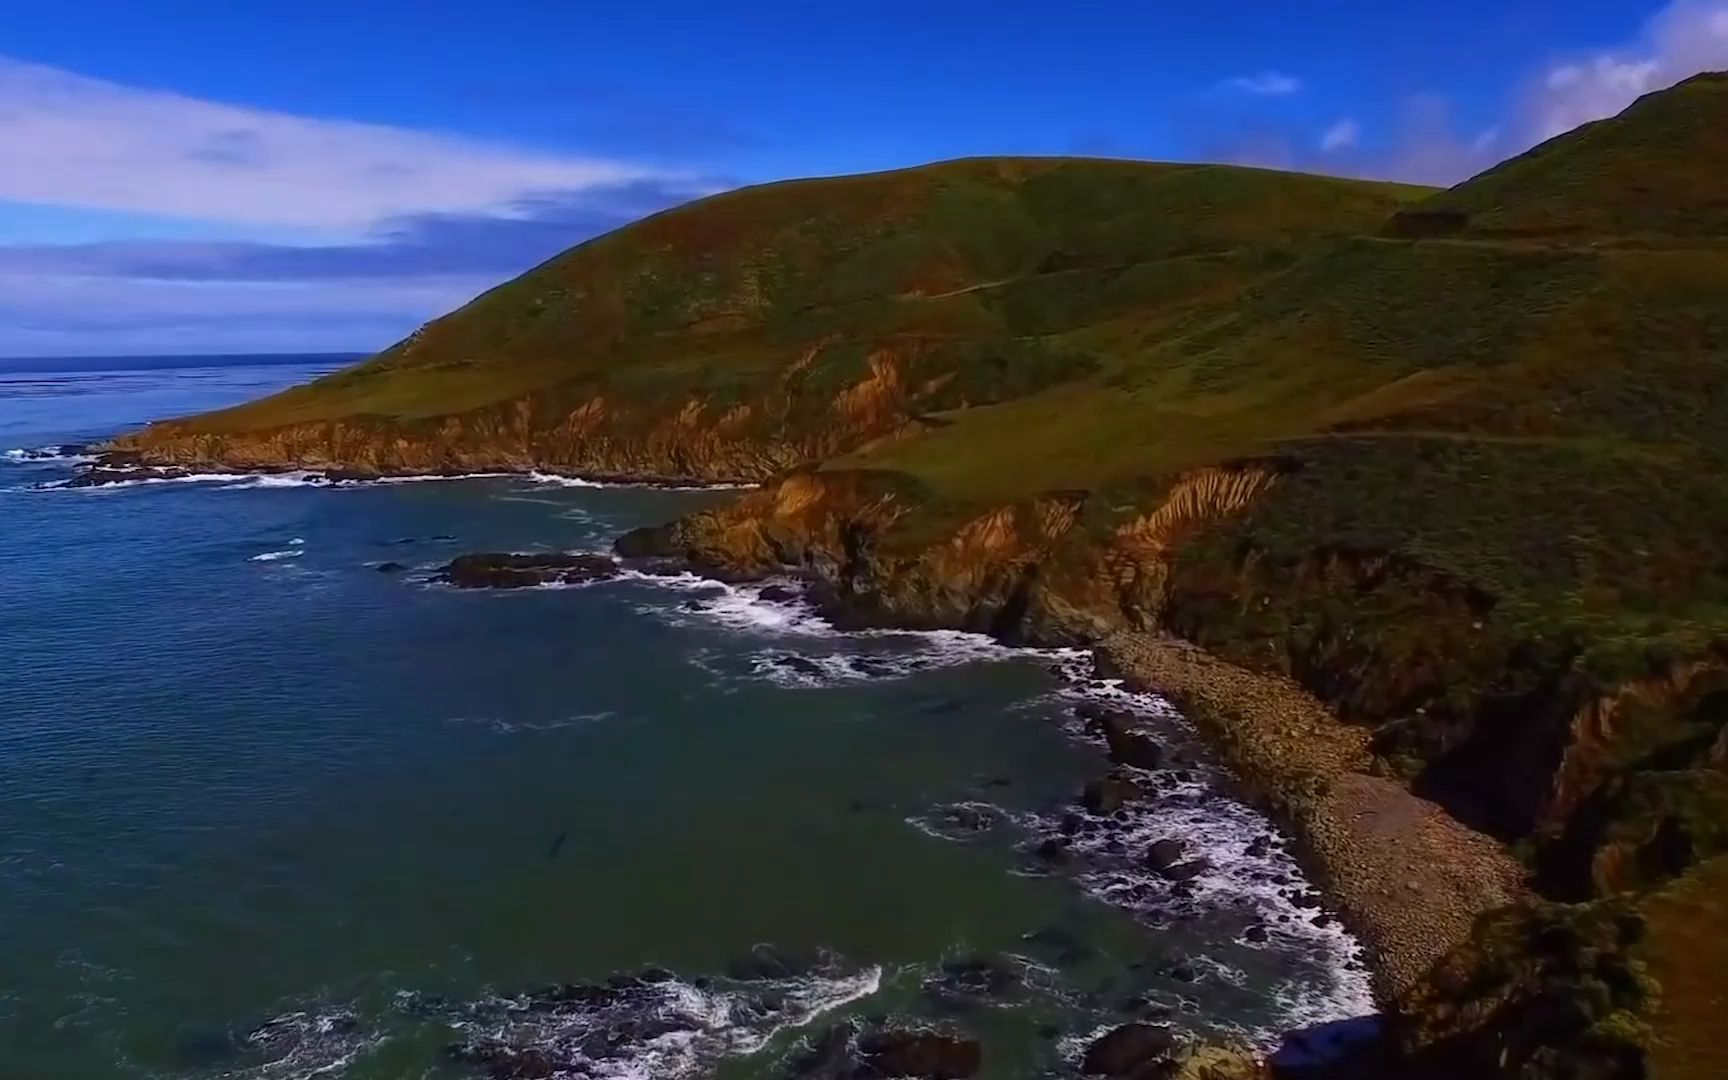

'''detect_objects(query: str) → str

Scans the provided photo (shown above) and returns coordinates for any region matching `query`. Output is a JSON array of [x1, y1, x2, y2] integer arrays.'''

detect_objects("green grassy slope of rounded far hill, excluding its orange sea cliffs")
[[148, 159, 1426, 430]]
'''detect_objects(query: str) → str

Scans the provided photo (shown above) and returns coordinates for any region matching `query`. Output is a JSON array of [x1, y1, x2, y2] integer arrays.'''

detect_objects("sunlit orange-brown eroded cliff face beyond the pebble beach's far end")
[[626, 461, 1279, 645]]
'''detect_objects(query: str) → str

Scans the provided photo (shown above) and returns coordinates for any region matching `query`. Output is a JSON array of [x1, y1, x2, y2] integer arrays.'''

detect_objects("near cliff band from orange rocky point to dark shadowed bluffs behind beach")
[[624, 461, 1728, 1080]]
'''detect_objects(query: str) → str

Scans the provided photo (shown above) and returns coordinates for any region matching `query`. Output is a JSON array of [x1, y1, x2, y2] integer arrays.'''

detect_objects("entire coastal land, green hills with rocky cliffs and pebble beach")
[[98, 76, 1728, 1078]]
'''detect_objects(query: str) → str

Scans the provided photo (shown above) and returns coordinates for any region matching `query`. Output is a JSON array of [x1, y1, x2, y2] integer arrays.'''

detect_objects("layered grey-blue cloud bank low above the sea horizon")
[[0, 181, 708, 356]]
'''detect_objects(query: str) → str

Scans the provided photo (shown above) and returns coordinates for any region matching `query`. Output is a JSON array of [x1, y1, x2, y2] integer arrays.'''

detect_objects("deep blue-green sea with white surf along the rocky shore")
[[0, 358, 1370, 1080]]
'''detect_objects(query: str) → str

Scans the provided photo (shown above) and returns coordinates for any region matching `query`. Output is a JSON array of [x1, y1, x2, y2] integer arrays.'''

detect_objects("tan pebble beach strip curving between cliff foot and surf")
[[1097, 632, 1528, 1007]]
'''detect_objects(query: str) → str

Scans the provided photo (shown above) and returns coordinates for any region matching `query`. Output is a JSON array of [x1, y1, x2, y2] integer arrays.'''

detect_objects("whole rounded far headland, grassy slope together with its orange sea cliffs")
[[121, 159, 1426, 479]]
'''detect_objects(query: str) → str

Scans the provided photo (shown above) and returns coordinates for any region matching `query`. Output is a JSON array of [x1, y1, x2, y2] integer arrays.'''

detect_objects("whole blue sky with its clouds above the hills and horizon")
[[0, 0, 1728, 356]]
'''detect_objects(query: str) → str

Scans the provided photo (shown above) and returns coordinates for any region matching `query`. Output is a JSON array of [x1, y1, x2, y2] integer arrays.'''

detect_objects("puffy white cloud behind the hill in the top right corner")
[[1522, 0, 1728, 142]]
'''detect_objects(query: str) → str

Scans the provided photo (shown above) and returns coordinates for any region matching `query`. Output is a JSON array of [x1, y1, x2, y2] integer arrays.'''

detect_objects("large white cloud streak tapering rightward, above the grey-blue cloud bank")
[[0, 57, 665, 233]]
